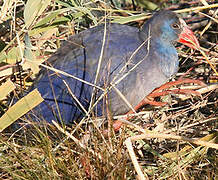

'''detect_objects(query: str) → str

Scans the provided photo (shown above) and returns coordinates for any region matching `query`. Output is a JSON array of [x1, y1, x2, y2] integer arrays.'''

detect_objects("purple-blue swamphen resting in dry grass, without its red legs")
[[31, 10, 198, 124]]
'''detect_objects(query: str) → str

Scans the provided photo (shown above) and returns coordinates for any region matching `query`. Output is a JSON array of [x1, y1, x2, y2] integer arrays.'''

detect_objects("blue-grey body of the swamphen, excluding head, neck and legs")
[[29, 24, 174, 124]]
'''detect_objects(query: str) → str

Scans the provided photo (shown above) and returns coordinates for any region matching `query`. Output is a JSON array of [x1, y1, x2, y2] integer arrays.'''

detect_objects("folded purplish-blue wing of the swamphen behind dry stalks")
[[30, 24, 145, 123]]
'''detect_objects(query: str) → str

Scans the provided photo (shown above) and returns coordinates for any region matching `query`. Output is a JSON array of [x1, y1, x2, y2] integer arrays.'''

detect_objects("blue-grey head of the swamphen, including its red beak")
[[141, 10, 200, 49]]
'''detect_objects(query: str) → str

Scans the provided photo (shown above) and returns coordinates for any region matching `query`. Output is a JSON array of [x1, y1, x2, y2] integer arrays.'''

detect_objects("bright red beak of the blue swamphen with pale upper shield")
[[178, 19, 200, 49]]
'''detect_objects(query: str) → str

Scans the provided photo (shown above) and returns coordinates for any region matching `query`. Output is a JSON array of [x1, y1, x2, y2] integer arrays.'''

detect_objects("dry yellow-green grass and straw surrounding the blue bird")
[[0, 0, 218, 179]]
